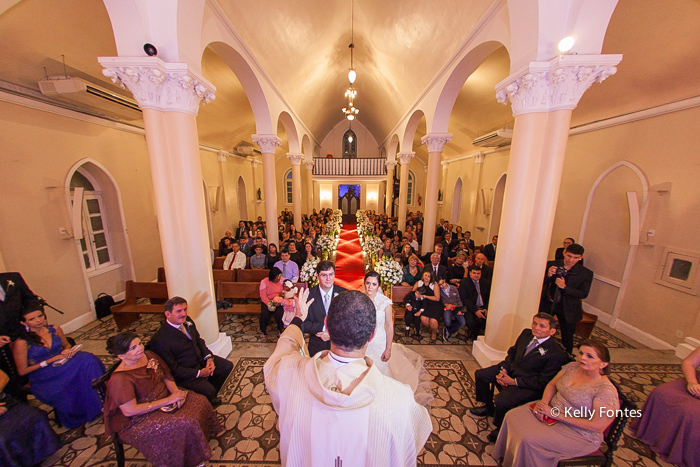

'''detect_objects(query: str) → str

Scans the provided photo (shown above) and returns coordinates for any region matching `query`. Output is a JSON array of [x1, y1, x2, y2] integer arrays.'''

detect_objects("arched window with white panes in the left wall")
[[70, 168, 114, 272]]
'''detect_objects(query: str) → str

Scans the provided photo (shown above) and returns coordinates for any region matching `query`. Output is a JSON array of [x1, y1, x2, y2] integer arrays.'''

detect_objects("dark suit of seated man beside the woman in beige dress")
[[474, 329, 569, 427]]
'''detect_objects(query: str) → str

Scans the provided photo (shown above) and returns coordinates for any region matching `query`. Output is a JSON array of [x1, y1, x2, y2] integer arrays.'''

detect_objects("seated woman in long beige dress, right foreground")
[[493, 340, 620, 467]]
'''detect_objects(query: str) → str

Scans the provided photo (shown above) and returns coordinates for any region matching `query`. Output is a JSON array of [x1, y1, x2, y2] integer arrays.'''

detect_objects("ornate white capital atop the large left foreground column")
[[97, 57, 216, 116]]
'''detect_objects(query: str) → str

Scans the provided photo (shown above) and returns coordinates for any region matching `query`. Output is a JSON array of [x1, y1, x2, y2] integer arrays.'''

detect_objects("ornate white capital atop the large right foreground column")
[[496, 54, 622, 117]]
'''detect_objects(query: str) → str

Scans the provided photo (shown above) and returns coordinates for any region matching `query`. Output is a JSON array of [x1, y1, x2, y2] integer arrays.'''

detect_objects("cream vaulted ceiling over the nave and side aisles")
[[0, 0, 700, 161]]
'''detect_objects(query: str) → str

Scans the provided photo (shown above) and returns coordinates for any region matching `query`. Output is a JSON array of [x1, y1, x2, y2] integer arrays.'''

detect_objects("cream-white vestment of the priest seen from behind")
[[263, 324, 432, 467]]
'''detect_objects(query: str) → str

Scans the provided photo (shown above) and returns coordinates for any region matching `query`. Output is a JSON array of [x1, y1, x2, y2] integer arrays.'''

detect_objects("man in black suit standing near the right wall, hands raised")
[[540, 243, 593, 353]]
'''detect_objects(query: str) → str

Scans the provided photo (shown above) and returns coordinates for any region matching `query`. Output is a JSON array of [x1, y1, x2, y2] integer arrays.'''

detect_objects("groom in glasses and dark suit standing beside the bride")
[[301, 261, 345, 357]]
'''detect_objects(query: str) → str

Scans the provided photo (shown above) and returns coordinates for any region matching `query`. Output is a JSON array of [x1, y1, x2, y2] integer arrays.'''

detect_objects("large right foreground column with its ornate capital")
[[474, 55, 622, 366]]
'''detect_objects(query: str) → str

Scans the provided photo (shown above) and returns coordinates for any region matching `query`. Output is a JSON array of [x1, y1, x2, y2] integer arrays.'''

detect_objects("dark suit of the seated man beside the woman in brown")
[[149, 318, 233, 401]]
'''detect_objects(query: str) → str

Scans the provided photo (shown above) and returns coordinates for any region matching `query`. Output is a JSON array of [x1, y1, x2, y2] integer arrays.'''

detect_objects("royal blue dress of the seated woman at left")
[[27, 326, 105, 428]]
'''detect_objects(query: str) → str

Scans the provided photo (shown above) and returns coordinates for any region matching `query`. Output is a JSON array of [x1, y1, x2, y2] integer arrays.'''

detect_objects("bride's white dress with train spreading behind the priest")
[[365, 290, 434, 409]]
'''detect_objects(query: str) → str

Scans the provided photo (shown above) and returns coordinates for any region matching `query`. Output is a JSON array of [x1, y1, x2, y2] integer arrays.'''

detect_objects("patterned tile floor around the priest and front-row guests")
[[31, 316, 681, 467]]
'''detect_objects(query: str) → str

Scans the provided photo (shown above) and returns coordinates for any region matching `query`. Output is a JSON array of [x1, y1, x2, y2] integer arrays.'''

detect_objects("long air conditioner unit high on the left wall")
[[39, 76, 142, 120]]
